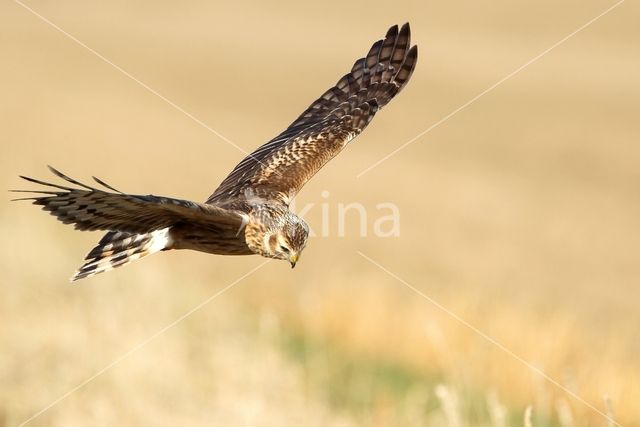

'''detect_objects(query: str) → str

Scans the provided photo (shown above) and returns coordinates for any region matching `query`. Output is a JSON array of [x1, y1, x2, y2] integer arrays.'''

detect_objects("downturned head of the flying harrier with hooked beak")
[[262, 211, 309, 268]]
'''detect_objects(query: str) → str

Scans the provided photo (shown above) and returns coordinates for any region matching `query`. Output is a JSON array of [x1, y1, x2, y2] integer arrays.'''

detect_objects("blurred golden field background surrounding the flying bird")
[[0, 1, 640, 427]]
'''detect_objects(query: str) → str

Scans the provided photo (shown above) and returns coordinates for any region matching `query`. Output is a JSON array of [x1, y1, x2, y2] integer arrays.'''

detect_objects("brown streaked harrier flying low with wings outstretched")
[[15, 24, 418, 281]]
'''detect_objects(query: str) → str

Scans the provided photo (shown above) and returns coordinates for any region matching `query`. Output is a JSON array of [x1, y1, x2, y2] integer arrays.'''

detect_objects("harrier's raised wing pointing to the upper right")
[[207, 23, 418, 204]]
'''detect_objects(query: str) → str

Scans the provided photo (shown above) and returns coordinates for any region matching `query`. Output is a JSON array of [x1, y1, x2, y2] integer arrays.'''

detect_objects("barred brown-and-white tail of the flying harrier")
[[71, 227, 171, 282]]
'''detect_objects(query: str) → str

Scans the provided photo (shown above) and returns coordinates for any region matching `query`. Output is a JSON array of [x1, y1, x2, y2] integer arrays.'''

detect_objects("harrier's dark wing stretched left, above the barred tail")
[[14, 166, 243, 234]]
